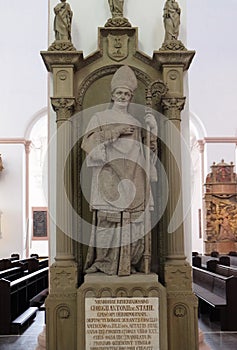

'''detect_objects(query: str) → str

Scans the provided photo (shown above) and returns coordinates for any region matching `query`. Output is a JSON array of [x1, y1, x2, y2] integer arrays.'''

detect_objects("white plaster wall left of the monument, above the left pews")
[[0, 0, 48, 257]]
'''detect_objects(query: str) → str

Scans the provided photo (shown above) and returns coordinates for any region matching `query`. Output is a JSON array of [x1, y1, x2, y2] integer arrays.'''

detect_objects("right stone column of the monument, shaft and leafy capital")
[[162, 97, 185, 263]]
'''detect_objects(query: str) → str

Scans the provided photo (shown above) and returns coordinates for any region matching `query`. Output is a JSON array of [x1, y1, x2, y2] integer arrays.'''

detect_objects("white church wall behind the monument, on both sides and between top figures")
[[0, 0, 237, 256]]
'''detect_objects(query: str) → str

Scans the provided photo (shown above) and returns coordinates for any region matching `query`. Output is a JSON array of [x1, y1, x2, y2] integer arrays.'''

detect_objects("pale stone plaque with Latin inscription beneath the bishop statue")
[[85, 298, 160, 350]]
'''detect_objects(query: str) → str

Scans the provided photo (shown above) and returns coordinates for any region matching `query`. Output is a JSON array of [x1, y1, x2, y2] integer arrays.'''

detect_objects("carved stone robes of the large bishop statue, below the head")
[[82, 109, 156, 275]]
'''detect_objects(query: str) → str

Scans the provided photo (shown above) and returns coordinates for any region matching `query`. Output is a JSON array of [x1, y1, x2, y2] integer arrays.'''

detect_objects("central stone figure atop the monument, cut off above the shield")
[[105, 0, 131, 27]]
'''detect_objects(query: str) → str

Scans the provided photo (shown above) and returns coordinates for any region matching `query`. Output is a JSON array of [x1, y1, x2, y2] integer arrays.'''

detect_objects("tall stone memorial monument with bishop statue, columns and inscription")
[[41, 0, 198, 350]]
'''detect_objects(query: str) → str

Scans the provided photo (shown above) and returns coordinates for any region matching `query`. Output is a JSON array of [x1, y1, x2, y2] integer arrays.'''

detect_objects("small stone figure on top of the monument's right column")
[[160, 0, 186, 51]]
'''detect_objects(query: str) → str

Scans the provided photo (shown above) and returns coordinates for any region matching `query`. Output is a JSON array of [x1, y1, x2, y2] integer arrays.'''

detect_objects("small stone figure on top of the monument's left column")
[[48, 0, 76, 51]]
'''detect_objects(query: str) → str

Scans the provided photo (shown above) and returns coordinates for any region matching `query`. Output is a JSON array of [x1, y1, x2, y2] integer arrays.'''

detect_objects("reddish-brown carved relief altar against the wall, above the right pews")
[[205, 160, 237, 254]]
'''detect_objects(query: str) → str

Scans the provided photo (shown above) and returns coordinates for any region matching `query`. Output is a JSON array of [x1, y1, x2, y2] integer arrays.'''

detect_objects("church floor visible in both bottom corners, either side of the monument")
[[0, 311, 237, 350]]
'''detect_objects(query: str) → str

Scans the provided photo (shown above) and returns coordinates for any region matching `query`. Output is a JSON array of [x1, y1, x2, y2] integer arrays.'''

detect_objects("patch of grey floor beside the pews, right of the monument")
[[199, 315, 237, 350]]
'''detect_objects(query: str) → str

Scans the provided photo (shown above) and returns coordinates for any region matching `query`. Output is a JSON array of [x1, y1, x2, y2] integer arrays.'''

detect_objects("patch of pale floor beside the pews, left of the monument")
[[0, 310, 45, 350]]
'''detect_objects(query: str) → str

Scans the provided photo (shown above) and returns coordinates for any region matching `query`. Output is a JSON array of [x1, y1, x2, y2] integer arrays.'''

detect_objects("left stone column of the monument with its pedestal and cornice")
[[41, 47, 81, 350]]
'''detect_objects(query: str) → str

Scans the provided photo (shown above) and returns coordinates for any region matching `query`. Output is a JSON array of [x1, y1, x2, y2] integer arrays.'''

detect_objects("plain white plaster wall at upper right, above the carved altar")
[[187, 0, 237, 137]]
